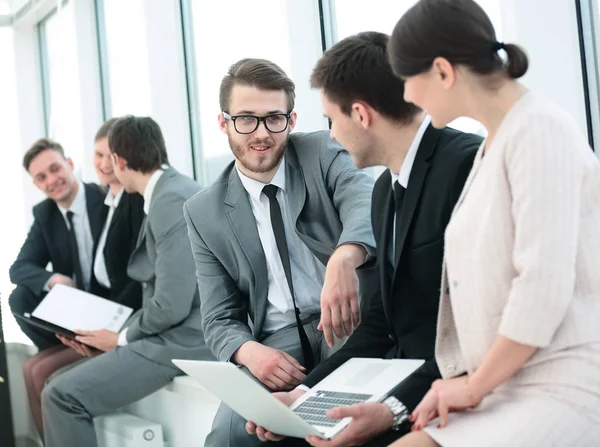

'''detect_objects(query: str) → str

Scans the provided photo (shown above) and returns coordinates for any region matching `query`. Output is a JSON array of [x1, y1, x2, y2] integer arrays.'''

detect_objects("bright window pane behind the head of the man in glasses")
[[190, 0, 327, 182]]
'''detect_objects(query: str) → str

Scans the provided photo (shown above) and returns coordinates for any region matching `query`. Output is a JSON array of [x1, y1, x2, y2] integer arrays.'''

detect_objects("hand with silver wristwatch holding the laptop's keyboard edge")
[[306, 402, 394, 447]]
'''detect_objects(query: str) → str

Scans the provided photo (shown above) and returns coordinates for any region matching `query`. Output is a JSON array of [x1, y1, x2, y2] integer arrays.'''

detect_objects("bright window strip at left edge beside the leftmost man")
[[0, 28, 31, 343]]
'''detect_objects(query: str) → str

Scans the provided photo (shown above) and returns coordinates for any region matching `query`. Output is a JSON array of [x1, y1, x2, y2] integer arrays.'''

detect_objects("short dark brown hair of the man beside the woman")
[[310, 31, 420, 123]]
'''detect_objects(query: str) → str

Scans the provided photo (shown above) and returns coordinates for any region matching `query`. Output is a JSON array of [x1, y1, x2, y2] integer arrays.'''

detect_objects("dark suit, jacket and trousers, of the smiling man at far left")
[[9, 184, 108, 350]]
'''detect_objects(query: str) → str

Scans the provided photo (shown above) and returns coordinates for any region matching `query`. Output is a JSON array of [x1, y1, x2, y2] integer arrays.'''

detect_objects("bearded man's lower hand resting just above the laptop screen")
[[233, 341, 306, 391]]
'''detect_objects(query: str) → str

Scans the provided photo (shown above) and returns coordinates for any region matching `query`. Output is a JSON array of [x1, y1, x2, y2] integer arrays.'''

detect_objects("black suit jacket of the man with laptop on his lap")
[[303, 125, 481, 411]]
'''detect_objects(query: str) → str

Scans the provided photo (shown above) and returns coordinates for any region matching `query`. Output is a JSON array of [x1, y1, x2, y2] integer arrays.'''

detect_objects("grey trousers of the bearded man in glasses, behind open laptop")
[[204, 319, 339, 447]]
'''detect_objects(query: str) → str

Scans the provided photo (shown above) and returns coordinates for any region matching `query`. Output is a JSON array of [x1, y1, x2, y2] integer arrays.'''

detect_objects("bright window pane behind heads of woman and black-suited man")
[[333, 0, 502, 134]]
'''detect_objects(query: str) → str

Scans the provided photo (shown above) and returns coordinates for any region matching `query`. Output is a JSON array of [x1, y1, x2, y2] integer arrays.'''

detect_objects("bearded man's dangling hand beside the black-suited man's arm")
[[318, 244, 366, 347]]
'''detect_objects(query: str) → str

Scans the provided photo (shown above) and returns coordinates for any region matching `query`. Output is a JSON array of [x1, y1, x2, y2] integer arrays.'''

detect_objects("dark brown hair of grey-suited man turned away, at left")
[[108, 115, 169, 174]]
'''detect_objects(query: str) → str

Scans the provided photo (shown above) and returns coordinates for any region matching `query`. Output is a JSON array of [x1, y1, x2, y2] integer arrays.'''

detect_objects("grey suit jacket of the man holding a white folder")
[[126, 168, 214, 365]]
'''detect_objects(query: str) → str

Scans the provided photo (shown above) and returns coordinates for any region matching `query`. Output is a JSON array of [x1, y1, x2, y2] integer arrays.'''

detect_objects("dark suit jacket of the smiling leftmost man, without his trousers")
[[9, 183, 108, 296]]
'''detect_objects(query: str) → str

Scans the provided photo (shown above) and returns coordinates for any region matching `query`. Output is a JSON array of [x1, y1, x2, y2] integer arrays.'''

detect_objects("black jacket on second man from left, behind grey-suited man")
[[104, 192, 145, 310]]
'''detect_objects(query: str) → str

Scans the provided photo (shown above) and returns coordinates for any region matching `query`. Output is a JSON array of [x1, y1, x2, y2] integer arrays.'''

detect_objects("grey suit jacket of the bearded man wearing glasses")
[[184, 131, 375, 361]]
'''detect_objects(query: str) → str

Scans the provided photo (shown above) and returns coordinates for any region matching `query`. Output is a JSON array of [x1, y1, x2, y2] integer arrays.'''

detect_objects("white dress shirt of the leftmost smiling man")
[[55, 182, 94, 290]]
